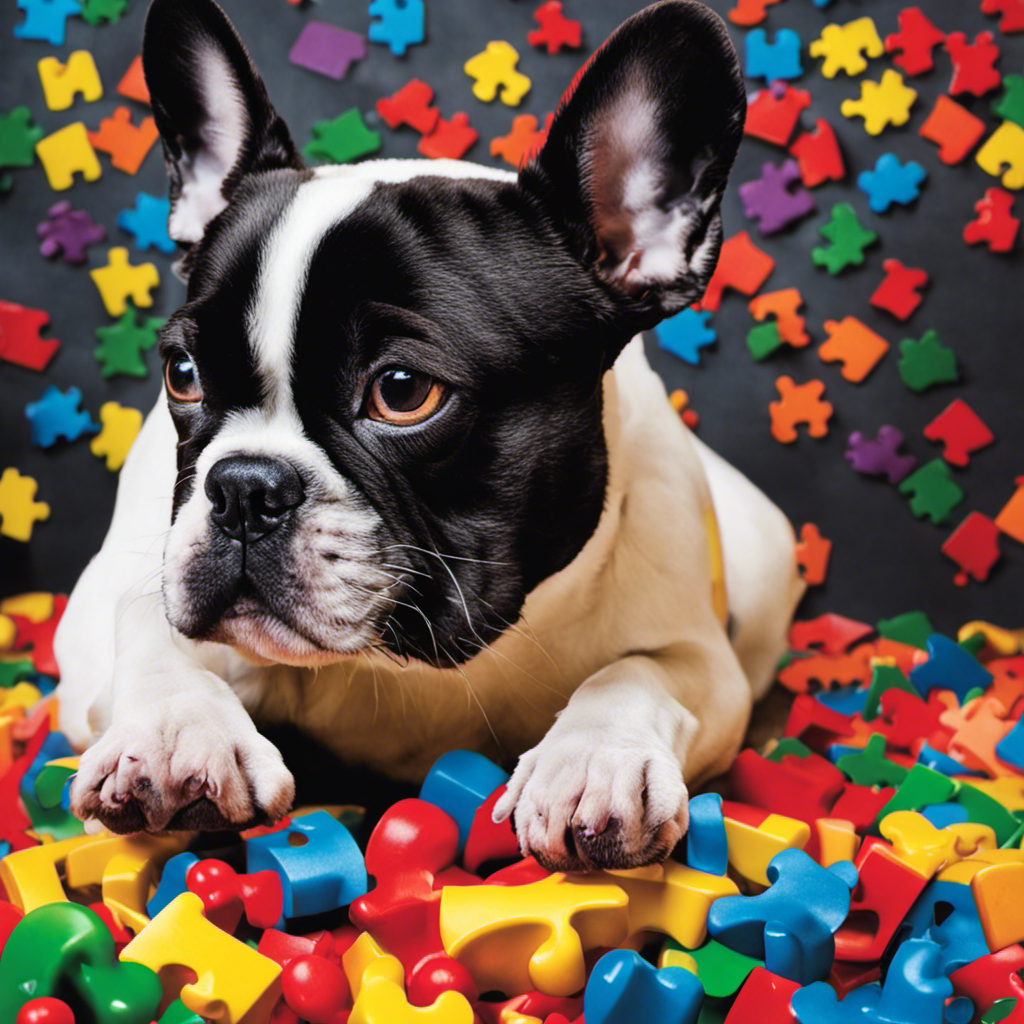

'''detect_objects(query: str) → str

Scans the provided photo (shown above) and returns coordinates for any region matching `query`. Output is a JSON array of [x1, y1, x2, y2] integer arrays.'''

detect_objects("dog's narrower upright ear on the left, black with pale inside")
[[142, 0, 303, 256]]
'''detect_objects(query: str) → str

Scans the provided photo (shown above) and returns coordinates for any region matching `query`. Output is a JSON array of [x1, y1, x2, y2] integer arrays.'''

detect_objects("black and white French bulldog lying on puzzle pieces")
[[56, 0, 803, 870]]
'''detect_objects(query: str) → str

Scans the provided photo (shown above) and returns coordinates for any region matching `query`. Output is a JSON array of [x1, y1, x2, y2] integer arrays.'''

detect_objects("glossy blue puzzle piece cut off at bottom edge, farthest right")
[[790, 937, 950, 1024]]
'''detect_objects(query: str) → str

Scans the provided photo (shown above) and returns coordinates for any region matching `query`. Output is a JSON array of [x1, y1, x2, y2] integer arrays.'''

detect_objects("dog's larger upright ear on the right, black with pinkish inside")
[[520, 0, 746, 327]]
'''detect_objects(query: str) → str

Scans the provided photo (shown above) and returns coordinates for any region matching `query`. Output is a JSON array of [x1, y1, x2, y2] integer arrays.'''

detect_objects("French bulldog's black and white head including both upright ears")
[[143, 0, 745, 665]]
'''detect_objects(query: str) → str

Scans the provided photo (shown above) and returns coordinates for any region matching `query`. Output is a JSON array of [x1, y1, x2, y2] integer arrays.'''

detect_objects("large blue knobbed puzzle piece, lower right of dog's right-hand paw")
[[708, 850, 856, 985]]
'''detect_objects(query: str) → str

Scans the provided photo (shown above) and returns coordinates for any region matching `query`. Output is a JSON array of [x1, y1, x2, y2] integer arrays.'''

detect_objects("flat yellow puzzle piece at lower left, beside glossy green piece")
[[121, 893, 281, 1024]]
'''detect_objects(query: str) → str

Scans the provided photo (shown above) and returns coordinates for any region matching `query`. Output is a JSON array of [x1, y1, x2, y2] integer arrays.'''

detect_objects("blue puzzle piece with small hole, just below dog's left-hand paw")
[[246, 811, 367, 918]]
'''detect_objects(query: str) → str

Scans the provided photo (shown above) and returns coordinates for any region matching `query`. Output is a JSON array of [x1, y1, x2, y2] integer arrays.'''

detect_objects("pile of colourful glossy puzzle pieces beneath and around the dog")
[[0, 594, 1024, 1024]]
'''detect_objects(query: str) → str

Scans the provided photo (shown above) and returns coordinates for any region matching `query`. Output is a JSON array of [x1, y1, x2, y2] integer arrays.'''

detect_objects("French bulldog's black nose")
[[206, 455, 306, 544]]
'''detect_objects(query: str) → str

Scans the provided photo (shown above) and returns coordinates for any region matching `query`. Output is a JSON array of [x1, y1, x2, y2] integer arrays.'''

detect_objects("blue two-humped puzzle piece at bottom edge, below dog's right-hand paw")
[[583, 949, 703, 1024]]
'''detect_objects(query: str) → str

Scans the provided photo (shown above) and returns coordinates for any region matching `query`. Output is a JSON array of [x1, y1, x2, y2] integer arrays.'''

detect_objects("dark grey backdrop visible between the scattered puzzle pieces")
[[0, 0, 1024, 630]]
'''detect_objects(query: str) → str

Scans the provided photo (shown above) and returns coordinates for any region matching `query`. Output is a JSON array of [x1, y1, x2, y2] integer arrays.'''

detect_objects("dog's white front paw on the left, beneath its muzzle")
[[71, 694, 295, 834]]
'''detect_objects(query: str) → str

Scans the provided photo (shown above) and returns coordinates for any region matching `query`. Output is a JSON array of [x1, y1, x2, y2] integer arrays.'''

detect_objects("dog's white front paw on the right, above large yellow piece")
[[494, 726, 688, 871]]
